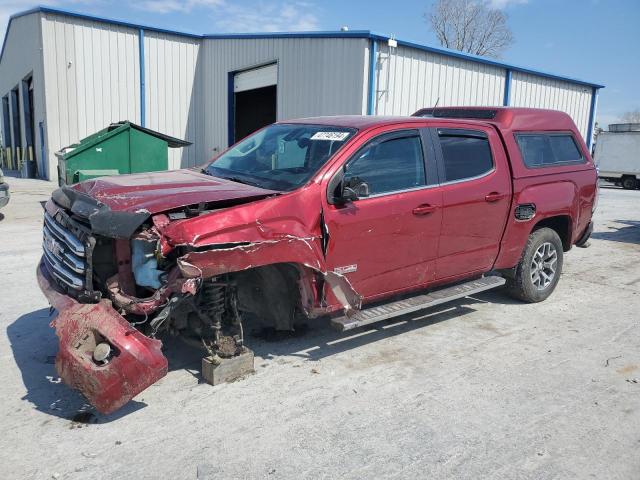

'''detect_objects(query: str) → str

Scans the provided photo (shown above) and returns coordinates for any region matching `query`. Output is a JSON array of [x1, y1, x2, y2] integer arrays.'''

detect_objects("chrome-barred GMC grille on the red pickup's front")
[[42, 212, 87, 290]]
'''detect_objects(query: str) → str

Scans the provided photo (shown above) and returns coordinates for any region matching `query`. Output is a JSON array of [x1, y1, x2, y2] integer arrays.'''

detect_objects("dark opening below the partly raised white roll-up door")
[[234, 85, 277, 142]]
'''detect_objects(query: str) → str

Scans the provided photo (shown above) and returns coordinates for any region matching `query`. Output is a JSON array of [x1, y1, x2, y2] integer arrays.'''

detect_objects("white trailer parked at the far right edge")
[[594, 124, 640, 190]]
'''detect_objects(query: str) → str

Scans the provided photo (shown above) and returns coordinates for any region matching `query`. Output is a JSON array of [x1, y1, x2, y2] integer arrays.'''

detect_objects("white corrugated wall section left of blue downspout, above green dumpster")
[[42, 13, 140, 180]]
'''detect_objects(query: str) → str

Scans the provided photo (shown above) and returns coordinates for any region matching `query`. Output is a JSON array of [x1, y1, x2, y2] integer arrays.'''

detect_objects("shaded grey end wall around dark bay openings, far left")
[[0, 13, 48, 177]]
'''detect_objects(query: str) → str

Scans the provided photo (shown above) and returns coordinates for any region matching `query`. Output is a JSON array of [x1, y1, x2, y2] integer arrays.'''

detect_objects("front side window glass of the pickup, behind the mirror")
[[344, 131, 426, 195]]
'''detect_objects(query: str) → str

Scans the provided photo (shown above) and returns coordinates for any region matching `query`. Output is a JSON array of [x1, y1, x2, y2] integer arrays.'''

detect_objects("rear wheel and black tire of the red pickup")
[[507, 228, 563, 303]]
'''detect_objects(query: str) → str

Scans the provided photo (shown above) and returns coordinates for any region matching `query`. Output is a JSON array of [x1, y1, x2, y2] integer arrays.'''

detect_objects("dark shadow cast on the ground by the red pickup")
[[7, 292, 515, 420]]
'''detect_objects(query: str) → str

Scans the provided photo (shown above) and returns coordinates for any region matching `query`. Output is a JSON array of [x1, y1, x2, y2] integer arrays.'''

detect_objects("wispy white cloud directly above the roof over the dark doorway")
[[215, 0, 320, 32]]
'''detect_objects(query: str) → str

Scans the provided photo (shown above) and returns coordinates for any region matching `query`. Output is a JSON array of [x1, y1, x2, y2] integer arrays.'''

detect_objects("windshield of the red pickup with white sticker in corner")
[[204, 124, 356, 191]]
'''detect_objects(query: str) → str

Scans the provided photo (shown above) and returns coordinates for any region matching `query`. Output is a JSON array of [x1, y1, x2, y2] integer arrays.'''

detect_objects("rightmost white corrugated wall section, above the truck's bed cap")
[[510, 72, 592, 139]]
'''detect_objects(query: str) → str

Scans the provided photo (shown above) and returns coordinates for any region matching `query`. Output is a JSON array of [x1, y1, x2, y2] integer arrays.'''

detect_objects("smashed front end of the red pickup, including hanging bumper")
[[38, 179, 360, 413]]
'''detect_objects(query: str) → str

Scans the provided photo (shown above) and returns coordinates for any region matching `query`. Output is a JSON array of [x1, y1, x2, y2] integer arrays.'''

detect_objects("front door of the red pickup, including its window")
[[325, 130, 441, 299]]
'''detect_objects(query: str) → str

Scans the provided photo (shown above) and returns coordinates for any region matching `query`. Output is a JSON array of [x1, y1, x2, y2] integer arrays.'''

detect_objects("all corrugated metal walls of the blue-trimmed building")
[[0, 12, 591, 180]]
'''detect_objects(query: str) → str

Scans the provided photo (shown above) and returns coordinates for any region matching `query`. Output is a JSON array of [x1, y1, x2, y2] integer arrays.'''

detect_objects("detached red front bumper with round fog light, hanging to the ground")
[[37, 260, 168, 414]]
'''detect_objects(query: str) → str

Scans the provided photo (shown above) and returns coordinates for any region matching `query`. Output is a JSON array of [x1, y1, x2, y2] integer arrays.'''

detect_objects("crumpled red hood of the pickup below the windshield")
[[72, 170, 277, 215]]
